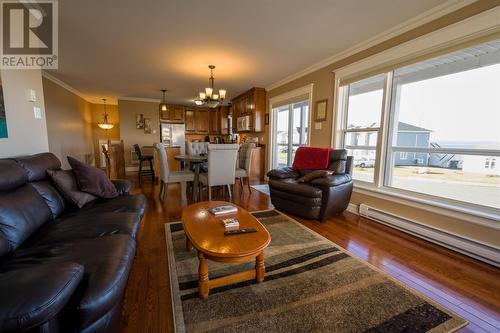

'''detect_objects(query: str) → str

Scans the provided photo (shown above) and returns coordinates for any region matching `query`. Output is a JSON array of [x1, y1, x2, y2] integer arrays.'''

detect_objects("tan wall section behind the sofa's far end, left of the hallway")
[[43, 78, 94, 168]]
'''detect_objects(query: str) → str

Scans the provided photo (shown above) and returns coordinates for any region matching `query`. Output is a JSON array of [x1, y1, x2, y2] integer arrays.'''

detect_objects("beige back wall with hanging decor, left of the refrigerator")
[[118, 100, 160, 167]]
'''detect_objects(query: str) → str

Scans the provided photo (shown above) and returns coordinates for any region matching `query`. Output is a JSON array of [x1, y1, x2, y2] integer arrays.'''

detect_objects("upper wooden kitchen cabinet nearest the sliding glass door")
[[231, 88, 266, 133]]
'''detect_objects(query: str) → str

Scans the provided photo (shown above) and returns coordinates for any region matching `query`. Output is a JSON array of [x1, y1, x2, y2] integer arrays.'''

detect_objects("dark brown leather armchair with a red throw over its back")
[[267, 149, 353, 222]]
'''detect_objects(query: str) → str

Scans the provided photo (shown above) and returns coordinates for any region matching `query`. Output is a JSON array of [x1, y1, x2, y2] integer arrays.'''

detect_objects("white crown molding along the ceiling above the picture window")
[[265, 0, 475, 91]]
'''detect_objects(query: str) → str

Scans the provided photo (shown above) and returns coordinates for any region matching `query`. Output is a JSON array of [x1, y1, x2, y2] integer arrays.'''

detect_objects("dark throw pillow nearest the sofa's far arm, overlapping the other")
[[68, 156, 118, 199]]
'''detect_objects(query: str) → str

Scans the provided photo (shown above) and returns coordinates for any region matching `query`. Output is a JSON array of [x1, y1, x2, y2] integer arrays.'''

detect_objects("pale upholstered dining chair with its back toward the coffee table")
[[200, 144, 240, 201]]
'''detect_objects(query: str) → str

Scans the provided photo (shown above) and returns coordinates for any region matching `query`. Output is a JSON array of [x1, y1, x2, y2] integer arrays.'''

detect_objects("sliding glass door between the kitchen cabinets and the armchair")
[[272, 100, 309, 168]]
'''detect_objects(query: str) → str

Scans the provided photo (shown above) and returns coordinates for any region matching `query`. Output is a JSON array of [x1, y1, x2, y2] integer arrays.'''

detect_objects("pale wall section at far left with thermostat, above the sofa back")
[[0, 70, 49, 157]]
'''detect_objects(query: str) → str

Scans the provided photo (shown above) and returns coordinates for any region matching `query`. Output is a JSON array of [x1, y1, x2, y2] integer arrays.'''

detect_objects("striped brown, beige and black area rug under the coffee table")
[[165, 210, 467, 333]]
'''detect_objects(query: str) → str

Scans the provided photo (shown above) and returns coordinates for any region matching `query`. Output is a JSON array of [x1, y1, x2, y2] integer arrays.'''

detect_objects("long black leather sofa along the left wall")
[[0, 153, 146, 333]]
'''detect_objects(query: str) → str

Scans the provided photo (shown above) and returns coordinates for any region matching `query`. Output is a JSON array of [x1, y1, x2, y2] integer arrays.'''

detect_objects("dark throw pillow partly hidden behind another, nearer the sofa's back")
[[47, 170, 97, 208]]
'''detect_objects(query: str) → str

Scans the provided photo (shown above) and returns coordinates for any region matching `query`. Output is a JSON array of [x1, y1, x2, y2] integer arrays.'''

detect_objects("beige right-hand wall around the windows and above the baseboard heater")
[[265, 0, 500, 247]]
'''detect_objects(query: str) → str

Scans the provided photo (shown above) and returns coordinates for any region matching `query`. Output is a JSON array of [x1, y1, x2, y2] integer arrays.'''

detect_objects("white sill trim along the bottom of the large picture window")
[[354, 181, 500, 230]]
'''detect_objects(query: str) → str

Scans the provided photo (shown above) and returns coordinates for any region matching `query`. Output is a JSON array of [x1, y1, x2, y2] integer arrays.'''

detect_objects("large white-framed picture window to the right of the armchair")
[[341, 40, 500, 209]]
